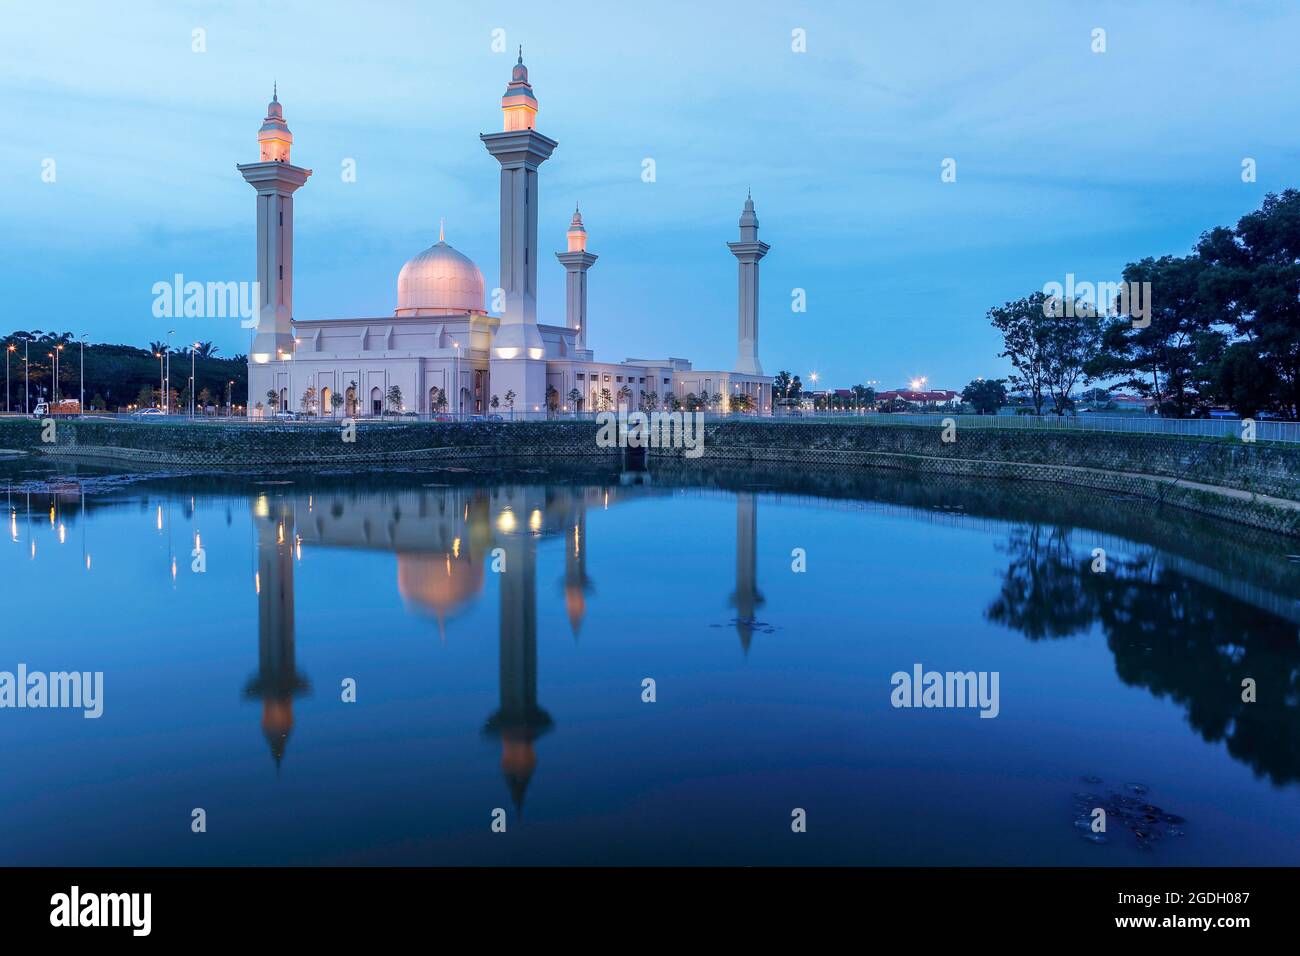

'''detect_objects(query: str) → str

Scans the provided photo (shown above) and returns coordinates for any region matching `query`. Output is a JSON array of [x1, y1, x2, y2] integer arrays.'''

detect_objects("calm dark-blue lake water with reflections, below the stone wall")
[[0, 459, 1300, 865]]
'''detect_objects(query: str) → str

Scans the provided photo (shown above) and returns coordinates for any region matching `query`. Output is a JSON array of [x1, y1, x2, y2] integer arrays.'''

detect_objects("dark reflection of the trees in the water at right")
[[985, 524, 1300, 784]]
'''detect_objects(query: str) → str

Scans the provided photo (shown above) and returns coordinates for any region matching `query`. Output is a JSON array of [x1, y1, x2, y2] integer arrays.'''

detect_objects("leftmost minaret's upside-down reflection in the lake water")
[[244, 494, 309, 770]]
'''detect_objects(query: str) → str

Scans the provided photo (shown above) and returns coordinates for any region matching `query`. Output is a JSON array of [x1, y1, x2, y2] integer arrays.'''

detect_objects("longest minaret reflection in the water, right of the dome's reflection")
[[484, 488, 553, 810]]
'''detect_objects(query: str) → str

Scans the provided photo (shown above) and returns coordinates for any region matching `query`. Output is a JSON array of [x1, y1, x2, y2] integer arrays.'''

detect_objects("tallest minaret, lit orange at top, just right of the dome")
[[480, 47, 558, 412]]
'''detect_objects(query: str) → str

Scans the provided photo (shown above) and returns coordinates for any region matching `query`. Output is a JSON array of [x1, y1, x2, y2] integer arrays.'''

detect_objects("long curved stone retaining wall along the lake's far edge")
[[0, 419, 1300, 535]]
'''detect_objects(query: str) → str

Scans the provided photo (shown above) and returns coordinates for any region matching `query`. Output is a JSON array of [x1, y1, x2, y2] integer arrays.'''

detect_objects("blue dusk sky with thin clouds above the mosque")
[[0, 0, 1300, 389]]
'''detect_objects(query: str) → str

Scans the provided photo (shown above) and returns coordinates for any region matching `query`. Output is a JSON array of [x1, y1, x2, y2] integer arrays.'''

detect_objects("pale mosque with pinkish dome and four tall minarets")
[[238, 51, 772, 418]]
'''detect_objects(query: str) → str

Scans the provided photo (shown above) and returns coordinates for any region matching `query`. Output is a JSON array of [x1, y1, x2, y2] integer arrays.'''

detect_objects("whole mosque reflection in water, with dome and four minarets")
[[244, 483, 763, 808]]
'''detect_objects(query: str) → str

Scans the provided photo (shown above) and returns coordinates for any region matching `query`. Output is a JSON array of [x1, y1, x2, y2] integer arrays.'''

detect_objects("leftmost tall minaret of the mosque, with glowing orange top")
[[237, 90, 312, 369]]
